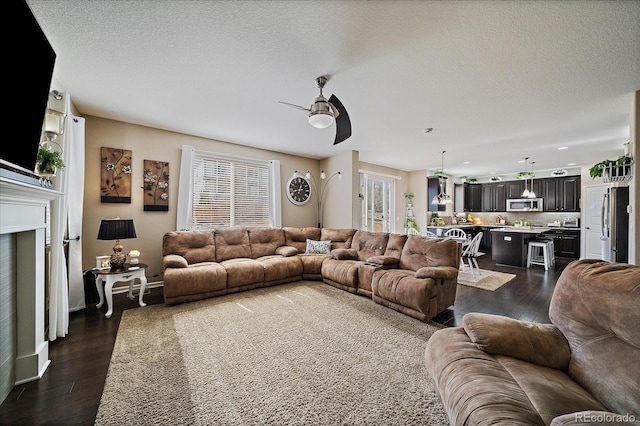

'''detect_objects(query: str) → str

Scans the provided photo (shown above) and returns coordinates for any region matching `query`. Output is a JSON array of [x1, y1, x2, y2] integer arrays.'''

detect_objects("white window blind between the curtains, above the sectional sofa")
[[191, 152, 272, 229]]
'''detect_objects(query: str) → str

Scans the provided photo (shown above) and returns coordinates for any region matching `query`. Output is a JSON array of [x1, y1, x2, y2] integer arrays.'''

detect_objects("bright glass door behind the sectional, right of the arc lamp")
[[360, 173, 395, 232]]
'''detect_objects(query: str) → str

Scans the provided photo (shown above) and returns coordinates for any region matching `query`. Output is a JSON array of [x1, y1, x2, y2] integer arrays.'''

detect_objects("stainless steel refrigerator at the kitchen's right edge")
[[600, 186, 629, 263]]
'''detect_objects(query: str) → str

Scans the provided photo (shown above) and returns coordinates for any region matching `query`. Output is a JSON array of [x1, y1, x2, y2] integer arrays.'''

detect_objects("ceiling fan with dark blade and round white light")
[[279, 76, 351, 145]]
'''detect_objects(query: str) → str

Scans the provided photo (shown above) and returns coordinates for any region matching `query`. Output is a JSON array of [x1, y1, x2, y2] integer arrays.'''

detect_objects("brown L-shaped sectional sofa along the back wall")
[[162, 227, 461, 322]]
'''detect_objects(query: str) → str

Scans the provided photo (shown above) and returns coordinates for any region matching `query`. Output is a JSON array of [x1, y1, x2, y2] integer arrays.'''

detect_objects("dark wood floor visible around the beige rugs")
[[0, 252, 569, 425]]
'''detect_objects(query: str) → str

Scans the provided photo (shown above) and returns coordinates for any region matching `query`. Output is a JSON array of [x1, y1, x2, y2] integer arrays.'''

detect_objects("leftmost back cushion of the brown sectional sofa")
[[162, 231, 216, 264]]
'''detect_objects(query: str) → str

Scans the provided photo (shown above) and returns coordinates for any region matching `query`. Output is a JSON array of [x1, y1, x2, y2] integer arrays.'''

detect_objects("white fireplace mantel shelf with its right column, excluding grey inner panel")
[[0, 177, 62, 385]]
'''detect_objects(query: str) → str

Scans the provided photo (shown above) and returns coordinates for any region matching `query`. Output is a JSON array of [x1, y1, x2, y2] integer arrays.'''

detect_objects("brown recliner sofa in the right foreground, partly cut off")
[[425, 259, 640, 426]]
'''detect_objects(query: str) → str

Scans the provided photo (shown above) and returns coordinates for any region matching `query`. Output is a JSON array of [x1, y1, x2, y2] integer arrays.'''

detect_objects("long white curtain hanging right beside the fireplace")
[[48, 94, 85, 341]]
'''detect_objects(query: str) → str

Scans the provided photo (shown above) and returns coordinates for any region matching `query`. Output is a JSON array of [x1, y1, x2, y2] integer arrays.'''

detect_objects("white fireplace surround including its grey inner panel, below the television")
[[0, 177, 62, 402]]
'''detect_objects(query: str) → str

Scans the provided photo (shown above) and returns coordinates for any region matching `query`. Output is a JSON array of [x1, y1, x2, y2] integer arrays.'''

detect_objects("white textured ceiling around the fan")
[[27, 0, 640, 177]]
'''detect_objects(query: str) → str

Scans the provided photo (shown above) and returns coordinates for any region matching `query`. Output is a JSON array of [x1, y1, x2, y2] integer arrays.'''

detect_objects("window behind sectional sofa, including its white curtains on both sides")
[[177, 146, 280, 230]]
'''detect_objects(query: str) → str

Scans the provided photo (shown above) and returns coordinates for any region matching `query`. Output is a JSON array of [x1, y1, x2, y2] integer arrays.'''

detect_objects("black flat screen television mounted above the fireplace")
[[0, 0, 56, 173]]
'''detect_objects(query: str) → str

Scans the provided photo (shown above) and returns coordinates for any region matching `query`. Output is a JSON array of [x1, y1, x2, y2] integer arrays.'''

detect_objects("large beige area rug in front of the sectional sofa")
[[96, 281, 449, 426]]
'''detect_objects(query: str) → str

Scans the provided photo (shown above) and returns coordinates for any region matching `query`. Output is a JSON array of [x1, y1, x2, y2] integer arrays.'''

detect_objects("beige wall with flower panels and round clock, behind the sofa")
[[82, 116, 328, 282]]
